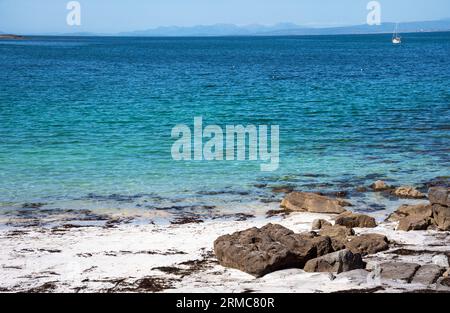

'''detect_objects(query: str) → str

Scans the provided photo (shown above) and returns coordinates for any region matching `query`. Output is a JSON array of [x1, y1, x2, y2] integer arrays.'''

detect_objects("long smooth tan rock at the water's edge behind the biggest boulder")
[[281, 192, 349, 214]]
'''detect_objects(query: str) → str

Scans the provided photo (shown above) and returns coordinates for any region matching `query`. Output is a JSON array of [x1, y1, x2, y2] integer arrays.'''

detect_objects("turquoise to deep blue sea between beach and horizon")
[[0, 33, 450, 211]]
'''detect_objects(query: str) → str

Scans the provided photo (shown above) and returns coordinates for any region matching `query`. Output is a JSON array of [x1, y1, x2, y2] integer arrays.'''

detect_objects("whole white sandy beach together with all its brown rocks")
[[0, 181, 450, 292]]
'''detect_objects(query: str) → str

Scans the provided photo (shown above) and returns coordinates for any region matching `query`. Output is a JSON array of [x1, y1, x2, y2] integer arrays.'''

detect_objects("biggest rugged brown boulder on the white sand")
[[214, 224, 333, 277]]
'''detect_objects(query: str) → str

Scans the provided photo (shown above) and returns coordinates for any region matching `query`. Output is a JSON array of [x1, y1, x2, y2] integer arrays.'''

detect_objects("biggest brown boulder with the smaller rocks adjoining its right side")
[[214, 224, 382, 277]]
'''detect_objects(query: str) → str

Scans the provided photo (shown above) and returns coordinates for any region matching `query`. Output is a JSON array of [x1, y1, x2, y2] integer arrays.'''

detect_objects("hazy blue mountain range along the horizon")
[[5, 18, 450, 37]]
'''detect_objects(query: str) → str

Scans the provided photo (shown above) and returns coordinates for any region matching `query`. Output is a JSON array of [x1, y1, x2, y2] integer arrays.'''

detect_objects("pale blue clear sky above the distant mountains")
[[0, 0, 450, 34]]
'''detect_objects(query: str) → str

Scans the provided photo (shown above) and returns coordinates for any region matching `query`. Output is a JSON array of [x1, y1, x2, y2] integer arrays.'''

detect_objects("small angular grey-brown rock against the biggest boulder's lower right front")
[[304, 250, 366, 274]]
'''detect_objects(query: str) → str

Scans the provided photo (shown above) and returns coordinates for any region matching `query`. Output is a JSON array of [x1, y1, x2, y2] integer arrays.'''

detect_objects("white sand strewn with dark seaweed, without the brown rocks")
[[0, 180, 450, 293]]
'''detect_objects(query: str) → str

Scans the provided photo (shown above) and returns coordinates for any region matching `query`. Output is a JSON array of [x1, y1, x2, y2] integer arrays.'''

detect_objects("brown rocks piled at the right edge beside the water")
[[387, 187, 450, 231]]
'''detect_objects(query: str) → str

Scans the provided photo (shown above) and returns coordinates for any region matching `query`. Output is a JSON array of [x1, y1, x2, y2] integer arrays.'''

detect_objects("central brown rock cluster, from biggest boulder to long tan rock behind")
[[214, 192, 389, 277]]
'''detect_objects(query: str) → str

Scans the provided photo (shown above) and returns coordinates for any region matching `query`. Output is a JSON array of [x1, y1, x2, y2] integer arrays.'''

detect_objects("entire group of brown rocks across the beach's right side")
[[214, 183, 450, 291]]
